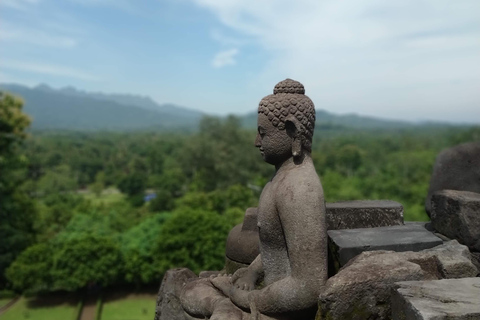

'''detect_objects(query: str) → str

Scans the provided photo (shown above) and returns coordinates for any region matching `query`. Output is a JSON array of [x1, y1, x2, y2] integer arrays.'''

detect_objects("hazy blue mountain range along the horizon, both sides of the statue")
[[0, 84, 450, 131]]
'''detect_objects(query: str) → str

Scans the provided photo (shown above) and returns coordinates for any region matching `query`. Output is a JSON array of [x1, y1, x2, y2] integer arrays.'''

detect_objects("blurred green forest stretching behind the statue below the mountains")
[[0, 92, 480, 294]]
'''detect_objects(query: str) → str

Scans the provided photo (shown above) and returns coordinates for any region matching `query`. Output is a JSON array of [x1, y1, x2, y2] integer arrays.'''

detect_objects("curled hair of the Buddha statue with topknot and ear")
[[258, 79, 315, 156]]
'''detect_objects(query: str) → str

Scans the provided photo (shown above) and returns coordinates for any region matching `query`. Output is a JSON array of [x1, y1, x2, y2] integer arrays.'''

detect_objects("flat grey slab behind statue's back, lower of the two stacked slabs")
[[328, 224, 443, 268]]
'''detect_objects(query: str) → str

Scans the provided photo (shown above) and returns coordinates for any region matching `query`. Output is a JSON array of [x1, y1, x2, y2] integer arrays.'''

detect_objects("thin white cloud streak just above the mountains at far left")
[[0, 60, 99, 81]]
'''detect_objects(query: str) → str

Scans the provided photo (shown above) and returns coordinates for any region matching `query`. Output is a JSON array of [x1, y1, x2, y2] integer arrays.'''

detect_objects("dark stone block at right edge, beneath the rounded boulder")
[[430, 190, 480, 252]]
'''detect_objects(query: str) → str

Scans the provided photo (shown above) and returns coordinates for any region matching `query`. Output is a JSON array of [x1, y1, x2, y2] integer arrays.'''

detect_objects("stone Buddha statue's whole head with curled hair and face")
[[255, 79, 315, 164]]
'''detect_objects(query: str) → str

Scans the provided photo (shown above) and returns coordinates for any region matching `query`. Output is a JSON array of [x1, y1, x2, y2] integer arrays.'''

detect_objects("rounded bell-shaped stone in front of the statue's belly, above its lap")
[[225, 208, 260, 264]]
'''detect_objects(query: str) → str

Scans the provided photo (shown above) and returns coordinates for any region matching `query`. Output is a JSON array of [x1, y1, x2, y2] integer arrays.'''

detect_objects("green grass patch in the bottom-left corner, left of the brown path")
[[0, 297, 77, 320]]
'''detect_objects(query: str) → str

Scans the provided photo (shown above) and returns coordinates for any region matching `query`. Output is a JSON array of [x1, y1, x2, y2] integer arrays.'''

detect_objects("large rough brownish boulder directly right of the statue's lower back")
[[317, 240, 476, 320]]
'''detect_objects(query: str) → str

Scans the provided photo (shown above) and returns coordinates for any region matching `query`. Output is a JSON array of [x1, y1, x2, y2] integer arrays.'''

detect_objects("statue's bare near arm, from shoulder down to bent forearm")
[[250, 177, 327, 313]]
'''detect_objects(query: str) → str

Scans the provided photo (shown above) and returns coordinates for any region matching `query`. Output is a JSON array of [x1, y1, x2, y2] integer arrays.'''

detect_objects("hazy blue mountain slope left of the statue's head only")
[[0, 84, 203, 130]]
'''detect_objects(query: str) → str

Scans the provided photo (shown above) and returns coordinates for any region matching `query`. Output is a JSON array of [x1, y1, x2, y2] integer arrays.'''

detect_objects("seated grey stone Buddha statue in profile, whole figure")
[[181, 79, 327, 320]]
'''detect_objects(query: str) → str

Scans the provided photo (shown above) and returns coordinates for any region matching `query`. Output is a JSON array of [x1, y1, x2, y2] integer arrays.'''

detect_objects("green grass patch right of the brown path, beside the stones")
[[100, 294, 156, 320]]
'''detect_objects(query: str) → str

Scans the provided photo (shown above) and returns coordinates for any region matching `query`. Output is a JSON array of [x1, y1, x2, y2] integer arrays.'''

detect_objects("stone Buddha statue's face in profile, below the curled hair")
[[255, 113, 292, 165]]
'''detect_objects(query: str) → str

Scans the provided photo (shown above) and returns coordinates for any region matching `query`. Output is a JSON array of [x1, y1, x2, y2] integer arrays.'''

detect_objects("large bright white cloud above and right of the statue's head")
[[192, 0, 480, 120]]
